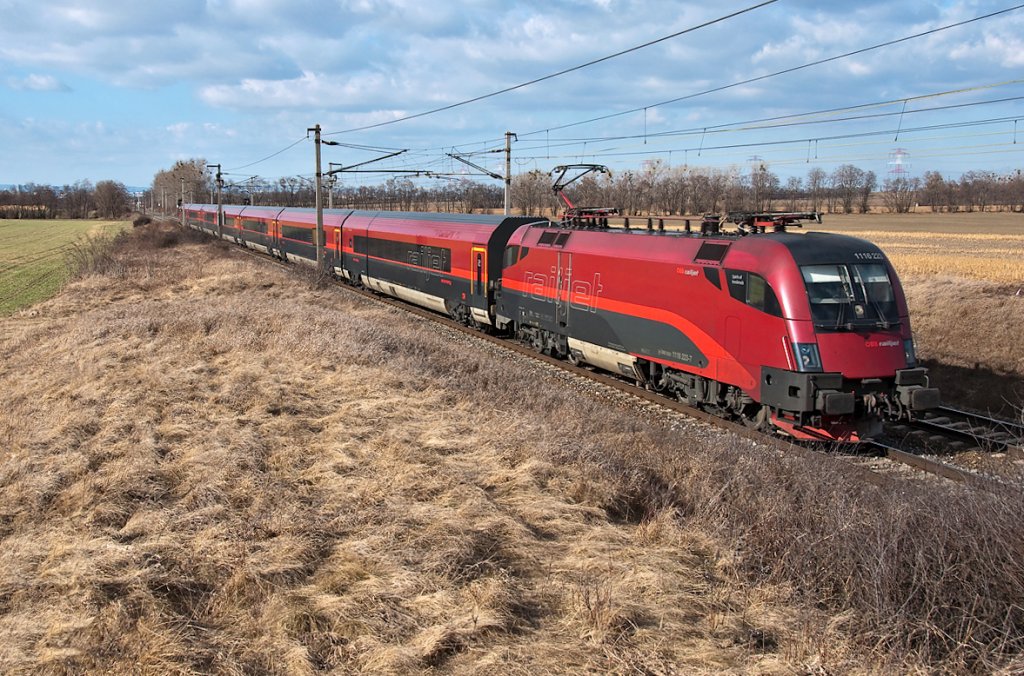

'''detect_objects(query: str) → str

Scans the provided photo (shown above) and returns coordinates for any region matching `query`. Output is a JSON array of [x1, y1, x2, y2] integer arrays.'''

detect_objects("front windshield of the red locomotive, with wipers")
[[800, 263, 899, 329]]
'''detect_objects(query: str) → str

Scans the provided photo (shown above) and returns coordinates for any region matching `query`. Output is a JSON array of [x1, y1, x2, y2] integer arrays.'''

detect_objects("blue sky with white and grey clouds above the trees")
[[0, 0, 1024, 186]]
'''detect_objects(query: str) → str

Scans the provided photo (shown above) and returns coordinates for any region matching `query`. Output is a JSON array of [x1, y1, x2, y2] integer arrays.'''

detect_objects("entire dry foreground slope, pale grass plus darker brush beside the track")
[[0, 223, 1024, 674]]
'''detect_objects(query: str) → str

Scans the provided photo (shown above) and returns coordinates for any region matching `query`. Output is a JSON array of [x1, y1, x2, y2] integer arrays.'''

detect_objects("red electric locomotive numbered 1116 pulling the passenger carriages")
[[496, 214, 938, 441]]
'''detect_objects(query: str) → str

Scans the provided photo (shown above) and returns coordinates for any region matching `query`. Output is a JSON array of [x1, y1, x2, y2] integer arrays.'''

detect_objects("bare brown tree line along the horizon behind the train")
[[0, 159, 1024, 218]]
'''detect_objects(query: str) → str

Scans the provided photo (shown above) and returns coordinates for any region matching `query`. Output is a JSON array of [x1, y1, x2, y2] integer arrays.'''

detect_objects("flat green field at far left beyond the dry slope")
[[0, 219, 128, 316]]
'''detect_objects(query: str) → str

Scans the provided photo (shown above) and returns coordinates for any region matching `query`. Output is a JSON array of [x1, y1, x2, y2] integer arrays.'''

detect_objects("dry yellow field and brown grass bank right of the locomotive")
[[814, 213, 1024, 417]]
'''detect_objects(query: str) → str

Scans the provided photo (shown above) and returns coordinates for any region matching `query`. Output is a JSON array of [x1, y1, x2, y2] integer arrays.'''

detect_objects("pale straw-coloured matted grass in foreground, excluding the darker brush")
[[0, 222, 831, 674]]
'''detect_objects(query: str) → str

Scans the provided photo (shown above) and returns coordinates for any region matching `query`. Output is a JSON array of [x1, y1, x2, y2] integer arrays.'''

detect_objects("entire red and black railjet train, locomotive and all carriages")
[[182, 204, 939, 441]]
